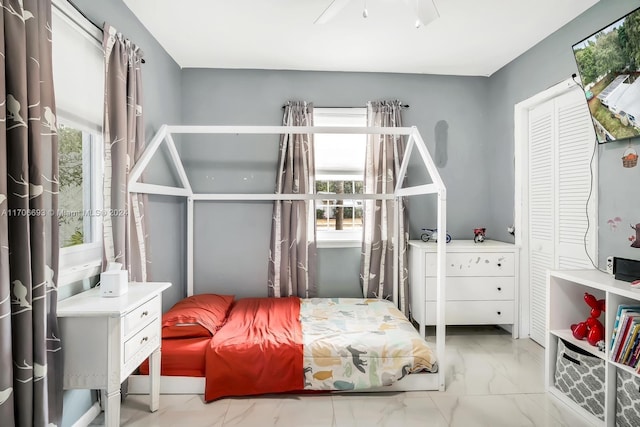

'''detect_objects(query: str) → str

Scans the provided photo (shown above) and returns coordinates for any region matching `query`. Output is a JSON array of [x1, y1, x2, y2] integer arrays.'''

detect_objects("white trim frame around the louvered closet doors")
[[514, 78, 598, 338]]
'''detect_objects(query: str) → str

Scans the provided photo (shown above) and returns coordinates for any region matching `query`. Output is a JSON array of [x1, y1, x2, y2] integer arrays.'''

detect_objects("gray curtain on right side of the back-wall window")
[[360, 101, 409, 315]]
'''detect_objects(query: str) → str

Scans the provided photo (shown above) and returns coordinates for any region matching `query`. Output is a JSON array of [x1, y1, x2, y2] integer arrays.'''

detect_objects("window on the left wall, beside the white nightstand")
[[51, 0, 104, 286]]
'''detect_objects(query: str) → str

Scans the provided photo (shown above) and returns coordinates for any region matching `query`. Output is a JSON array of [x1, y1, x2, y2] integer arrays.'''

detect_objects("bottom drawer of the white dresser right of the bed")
[[427, 301, 514, 325]]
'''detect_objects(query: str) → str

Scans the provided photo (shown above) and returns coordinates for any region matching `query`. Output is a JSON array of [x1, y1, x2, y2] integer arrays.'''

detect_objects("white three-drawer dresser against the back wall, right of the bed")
[[409, 240, 518, 338]]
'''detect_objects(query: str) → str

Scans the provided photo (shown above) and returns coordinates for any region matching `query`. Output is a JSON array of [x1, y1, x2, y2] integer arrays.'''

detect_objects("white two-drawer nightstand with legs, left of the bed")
[[58, 282, 171, 427]]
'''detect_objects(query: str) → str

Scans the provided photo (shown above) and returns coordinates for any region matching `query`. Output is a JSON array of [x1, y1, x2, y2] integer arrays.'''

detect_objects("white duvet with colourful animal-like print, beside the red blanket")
[[300, 298, 437, 390]]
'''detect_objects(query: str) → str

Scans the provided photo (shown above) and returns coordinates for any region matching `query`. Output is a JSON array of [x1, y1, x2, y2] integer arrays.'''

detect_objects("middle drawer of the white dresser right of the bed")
[[425, 277, 515, 301]]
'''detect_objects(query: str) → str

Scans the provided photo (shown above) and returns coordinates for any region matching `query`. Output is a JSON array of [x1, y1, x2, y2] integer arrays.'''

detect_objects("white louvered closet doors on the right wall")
[[528, 88, 597, 345]]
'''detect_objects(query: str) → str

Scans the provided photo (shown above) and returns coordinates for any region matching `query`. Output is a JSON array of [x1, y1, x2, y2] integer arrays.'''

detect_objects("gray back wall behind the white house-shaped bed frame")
[[181, 69, 491, 296]]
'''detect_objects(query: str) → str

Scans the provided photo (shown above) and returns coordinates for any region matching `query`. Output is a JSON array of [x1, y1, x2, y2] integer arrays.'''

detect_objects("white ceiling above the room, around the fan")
[[124, 0, 598, 76]]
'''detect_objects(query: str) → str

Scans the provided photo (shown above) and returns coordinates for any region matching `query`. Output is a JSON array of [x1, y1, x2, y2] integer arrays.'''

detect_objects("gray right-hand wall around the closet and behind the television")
[[484, 0, 640, 261]]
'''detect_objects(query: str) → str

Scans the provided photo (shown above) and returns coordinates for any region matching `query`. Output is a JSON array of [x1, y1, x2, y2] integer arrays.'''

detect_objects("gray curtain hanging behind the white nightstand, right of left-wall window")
[[103, 25, 149, 282]]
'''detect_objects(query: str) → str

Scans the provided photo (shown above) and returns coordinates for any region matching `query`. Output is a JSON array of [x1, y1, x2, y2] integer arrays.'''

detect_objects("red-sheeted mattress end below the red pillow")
[[140, 337, 211, 377]]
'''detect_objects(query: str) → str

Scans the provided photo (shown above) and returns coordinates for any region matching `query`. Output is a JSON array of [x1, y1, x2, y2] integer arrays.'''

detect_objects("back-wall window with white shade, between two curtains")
[[313, 108, 367, 247]]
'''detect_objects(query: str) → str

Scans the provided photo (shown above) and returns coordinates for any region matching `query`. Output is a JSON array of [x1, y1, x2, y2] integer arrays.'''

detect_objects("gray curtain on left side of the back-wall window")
[[268, 101, 317, 298]]
